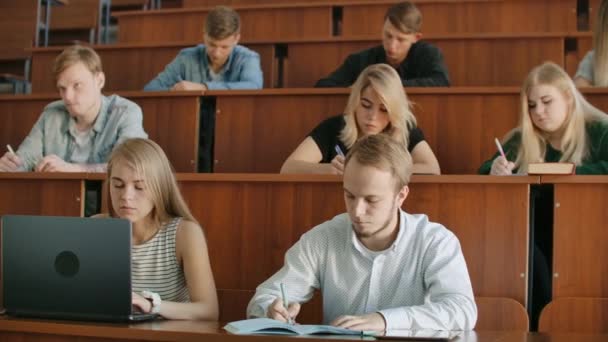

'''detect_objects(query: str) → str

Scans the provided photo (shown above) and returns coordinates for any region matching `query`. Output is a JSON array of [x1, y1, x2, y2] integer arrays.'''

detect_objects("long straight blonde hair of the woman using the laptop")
[[108, 138, 197, 227]]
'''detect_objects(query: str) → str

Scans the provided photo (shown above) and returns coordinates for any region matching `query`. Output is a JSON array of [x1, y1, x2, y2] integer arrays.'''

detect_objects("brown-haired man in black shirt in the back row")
[[315, 1, 450, 87]]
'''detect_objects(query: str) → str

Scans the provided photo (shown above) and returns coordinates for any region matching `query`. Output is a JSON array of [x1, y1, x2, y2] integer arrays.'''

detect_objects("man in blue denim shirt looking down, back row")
[[144, 6, 263, 91]]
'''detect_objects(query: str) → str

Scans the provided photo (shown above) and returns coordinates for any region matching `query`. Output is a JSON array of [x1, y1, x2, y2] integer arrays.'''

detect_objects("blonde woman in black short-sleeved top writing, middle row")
[[281, 64, 440, 174]]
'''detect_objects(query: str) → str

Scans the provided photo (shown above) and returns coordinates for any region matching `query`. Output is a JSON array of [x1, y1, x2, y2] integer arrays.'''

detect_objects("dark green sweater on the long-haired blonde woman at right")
[[478, 121, 608, 175]]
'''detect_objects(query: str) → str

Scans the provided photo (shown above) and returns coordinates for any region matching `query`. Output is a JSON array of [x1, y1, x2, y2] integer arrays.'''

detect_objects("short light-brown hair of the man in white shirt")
[[344, 134, 413, 190]]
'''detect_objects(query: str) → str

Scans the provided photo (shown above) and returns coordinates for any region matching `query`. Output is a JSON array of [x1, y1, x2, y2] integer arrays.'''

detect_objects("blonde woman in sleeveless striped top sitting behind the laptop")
[[97, 139, 218, 321]]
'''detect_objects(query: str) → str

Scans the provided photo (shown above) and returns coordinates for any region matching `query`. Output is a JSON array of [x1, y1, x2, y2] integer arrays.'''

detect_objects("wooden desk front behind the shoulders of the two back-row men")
[[31, 32, 568, 93]]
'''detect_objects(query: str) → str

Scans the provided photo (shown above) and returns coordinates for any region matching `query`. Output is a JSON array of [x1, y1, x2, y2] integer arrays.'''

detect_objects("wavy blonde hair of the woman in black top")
[[340, 64, 416, 149]]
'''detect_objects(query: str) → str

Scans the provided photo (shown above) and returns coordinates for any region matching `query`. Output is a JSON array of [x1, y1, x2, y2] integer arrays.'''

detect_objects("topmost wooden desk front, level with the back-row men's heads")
[[115, 0, 577, 43]]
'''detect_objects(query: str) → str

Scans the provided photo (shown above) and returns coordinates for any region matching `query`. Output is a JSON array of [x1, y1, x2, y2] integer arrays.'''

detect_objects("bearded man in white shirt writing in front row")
[[247, 134, 477, 331]]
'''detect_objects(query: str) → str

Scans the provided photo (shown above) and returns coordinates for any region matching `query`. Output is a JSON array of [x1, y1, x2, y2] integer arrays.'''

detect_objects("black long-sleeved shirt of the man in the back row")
[[315, 41, 450, 87]]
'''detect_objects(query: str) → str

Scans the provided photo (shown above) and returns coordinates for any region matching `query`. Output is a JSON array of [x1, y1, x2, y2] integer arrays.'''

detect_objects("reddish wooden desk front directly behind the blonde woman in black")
[[207, 88, 519, 174]]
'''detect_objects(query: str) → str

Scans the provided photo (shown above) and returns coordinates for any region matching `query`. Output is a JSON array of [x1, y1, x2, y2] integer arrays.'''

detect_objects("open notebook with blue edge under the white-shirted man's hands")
[[224, 318, 373, 335]]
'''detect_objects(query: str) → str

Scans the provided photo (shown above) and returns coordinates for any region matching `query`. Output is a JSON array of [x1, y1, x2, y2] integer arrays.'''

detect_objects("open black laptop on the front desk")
[[0, 215, 158, 322]]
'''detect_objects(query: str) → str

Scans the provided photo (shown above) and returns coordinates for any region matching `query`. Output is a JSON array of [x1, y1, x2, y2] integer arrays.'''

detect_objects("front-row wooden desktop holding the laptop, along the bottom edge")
[[0, 317, 608, 342]]
